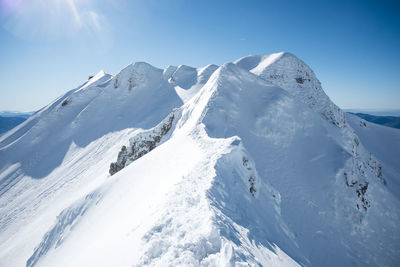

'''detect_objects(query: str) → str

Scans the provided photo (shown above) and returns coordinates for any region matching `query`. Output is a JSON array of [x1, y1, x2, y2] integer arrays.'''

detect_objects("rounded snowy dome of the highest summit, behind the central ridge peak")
[[235, 52, 345, 127]]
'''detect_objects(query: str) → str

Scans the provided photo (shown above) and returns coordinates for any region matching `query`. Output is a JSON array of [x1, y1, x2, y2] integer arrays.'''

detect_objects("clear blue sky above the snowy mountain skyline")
[[0, 0, 400, 111]]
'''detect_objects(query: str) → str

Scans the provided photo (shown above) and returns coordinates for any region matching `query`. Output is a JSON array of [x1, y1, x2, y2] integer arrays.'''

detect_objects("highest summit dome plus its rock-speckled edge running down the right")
[[235, 53, 390, 229]]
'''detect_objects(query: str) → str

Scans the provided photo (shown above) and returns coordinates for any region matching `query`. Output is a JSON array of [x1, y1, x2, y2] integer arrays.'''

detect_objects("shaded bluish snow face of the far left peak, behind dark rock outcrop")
[[0, 63, 182, 178]]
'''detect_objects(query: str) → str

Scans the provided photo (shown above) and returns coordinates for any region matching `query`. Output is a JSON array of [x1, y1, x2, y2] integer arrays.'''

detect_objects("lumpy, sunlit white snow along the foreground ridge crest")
[[135, 136, 229, 266]]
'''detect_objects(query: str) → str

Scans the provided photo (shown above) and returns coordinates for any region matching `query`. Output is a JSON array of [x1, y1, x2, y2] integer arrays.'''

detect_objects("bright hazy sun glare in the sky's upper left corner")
[[0, 0, 107, 39]]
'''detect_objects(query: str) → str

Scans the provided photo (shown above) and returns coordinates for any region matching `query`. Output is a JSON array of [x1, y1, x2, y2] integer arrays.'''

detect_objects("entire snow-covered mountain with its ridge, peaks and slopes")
[[0, 53, 400, 266]]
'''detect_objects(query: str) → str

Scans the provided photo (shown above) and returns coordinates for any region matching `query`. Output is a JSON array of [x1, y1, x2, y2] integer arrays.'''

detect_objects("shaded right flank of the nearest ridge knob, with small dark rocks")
[[207, 143, 306, 266]]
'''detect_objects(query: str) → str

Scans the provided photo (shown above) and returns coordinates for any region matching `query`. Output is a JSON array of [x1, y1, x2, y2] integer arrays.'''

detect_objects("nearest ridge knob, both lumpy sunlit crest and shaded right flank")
[[134, 129, 298, 266]]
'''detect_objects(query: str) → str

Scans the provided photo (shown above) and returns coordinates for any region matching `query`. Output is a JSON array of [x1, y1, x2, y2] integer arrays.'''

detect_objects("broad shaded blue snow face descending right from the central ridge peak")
[[189, 64, 398, 266]]
